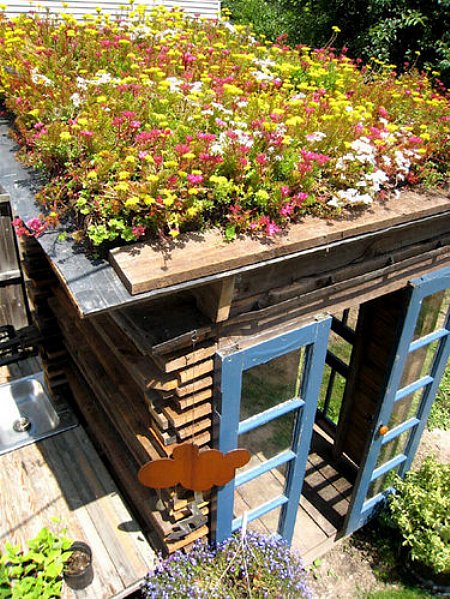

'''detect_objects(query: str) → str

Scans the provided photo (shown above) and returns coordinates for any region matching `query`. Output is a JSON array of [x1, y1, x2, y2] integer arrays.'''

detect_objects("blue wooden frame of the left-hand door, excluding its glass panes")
[[213, 317, 331, 543]]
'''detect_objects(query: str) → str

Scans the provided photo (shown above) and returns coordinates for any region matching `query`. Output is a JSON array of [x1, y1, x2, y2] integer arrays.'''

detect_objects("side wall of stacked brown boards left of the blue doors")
[[41, 276, 216, 552]]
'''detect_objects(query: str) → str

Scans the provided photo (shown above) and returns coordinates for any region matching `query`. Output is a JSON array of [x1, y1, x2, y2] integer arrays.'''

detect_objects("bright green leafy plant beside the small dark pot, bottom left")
[[0, 528, 72, 599]]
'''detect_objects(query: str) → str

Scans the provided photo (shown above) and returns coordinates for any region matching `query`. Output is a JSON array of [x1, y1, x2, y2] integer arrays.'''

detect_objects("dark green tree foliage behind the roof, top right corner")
[[226, 0, 450, 85]]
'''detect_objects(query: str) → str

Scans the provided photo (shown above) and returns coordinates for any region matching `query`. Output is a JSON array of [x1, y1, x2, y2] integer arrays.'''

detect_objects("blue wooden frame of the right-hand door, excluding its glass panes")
[[344, 267, 450, 534]]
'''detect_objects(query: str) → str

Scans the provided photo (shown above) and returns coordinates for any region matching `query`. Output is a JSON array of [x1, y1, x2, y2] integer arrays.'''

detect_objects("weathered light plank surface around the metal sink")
[[0, 360, 155, 599]]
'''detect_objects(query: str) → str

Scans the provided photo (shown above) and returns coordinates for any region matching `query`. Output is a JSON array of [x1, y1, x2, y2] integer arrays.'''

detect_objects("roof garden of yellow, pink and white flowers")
[[0, 6, 450, 250]]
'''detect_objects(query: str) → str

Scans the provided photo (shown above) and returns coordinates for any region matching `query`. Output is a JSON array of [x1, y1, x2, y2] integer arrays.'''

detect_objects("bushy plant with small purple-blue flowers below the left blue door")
[[142, 532, 311, 599]]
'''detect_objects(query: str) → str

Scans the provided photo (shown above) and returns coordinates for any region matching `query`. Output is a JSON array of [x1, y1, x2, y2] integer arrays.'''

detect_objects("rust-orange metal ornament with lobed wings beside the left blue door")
[[138, 443, 251, 491]]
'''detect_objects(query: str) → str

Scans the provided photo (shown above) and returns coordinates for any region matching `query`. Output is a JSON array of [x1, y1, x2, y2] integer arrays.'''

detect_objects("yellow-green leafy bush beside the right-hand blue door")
[[389, 457, 450, 592]]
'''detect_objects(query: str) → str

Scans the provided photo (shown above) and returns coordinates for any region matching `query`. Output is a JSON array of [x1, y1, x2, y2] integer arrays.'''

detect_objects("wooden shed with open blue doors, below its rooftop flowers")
[[0, 110, 450, 560]]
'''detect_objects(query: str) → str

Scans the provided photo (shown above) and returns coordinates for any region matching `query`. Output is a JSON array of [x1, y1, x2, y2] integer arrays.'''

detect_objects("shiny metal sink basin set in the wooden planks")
[[0, 373, 78, 455]]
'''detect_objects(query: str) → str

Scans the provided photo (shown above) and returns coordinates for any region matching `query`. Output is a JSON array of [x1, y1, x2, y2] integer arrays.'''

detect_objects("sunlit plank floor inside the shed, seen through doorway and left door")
[[235, 431, 353, 565]]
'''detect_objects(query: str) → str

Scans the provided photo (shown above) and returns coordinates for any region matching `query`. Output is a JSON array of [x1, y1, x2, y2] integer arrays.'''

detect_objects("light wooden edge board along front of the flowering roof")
[[109, 191, 450, 295]]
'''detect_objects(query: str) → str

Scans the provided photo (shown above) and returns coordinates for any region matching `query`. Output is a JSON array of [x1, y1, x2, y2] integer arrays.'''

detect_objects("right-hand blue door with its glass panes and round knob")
[[344, 267, 450, 534]]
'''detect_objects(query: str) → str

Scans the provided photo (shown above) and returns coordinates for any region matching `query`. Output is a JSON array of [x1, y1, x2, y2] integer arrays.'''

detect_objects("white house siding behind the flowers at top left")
[[2, 0, 220, 19]]
